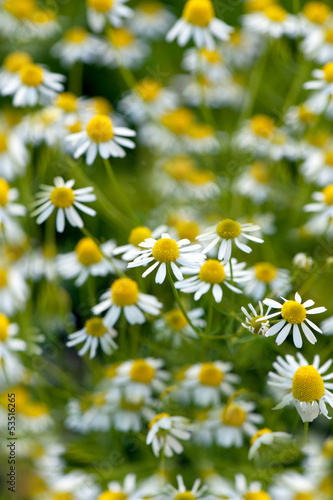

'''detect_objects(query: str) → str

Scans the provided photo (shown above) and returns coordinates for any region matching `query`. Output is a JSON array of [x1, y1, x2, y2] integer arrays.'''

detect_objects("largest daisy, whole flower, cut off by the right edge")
[[268, 353, 333, 422]]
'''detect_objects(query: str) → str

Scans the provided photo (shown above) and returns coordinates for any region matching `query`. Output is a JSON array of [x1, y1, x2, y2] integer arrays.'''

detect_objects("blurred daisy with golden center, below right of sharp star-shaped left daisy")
[[56, 237, 125, 287]]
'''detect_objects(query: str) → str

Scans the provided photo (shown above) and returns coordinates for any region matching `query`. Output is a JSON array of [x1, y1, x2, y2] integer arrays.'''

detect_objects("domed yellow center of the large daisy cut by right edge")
[[292, 365, 325, 403]]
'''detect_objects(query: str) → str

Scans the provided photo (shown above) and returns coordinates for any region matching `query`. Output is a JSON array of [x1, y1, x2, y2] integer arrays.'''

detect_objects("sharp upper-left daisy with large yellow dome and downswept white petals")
[[66, 115, 136, 165]]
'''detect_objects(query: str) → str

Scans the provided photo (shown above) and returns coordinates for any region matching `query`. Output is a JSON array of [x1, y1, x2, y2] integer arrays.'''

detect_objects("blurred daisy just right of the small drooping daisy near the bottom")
[[210, 400, 264, 448]]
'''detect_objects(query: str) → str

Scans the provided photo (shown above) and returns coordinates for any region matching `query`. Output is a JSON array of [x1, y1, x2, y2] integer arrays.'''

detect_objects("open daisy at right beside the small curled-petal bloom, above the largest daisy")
[[263, 292, 326, 348]]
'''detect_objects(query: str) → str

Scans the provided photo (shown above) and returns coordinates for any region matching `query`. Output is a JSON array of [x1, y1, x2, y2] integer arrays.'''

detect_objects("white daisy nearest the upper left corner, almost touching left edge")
[[2, 63, 66, 107]]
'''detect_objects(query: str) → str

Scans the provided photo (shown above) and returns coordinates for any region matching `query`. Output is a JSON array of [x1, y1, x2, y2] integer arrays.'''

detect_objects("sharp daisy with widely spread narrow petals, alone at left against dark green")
[[31, 177, 96, 233]]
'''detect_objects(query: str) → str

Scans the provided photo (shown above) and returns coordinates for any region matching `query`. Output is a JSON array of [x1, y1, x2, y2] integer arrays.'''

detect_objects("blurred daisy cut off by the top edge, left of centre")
[[87, 0, 133, 33]]
